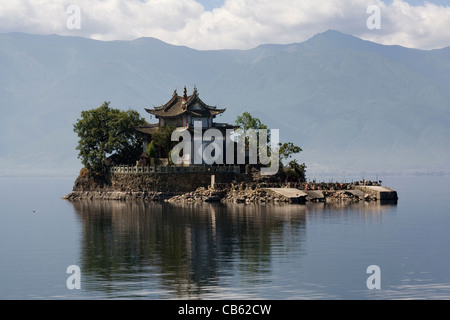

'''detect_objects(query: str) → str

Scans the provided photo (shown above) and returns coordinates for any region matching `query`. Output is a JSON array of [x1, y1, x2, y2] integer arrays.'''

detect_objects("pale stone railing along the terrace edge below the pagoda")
[[109, 166, 240, 174]]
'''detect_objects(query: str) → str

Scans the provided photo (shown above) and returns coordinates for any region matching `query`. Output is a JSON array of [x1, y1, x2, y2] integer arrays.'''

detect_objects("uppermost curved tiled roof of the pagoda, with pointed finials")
[[145, 87, 226, 118]]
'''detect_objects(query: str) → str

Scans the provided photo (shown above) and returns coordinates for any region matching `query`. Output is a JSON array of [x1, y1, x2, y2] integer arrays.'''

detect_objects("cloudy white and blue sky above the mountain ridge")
[[0, 0, 450, 50]]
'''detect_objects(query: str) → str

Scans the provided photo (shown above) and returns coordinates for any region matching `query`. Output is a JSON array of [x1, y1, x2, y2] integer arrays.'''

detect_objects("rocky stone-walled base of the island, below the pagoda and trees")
[[64, 166, 398, 203]]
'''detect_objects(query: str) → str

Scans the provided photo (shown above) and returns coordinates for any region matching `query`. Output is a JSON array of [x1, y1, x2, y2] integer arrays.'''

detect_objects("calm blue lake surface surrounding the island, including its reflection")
[[0, 177, 450, 299]]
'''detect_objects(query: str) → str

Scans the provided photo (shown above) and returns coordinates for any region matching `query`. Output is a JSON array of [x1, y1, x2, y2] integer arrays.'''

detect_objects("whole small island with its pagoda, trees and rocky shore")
[[64, 87, 397, 203]]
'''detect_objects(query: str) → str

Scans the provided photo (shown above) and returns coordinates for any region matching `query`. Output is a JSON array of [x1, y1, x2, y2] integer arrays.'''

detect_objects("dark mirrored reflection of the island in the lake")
[[72, 201, 394, 298]]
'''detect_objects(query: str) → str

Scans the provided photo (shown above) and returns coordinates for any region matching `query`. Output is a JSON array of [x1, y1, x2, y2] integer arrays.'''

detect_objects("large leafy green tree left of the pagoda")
[[73, 102, 146, 171]]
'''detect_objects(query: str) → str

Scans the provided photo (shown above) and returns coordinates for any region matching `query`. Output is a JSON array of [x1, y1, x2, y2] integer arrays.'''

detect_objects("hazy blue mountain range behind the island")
[[0, 30, 450, 178]]
